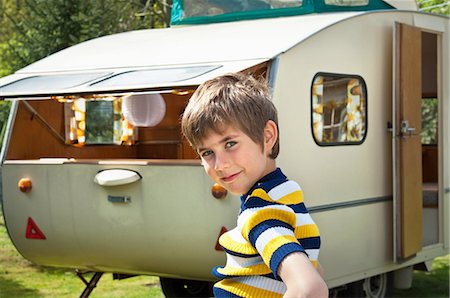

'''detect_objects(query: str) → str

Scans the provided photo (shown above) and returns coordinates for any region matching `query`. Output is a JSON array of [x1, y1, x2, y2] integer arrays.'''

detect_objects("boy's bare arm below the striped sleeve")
[[278, 252, 328, 298]]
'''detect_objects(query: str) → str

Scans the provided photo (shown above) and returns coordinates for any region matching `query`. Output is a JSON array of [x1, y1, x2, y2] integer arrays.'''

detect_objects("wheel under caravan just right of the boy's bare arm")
[[337, 273, 393, 298]]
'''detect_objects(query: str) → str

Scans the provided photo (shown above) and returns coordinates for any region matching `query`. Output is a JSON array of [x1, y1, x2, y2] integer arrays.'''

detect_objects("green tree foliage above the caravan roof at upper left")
[[0, 0, 169, 76]]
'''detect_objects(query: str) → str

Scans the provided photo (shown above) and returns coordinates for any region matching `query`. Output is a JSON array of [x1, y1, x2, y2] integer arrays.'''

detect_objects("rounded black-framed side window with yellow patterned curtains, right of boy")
[[311, 73, 367, 146]]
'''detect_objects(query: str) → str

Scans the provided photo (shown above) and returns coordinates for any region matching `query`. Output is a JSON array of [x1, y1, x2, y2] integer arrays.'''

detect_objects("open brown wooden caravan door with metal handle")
[[393, 23, 423, 261]]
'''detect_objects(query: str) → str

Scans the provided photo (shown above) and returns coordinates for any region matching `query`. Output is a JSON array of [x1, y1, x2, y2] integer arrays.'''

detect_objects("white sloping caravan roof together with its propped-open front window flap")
[[0, 12, 361, 98]]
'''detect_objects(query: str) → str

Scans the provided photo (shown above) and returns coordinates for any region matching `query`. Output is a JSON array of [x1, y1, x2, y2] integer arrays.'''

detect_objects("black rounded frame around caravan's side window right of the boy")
[[310, 72, 369, 147]]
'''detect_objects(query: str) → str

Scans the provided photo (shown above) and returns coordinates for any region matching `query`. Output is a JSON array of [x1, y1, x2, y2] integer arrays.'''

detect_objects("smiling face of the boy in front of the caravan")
[[197, 125, 276, 195]]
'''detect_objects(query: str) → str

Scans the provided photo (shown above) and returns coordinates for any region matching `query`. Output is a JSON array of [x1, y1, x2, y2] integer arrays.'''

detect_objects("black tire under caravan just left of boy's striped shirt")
[[159, 277, 213, 297]]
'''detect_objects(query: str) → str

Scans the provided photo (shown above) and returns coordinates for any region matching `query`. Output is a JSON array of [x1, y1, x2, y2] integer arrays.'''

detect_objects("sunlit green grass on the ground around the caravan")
[[0, 209, 450, 298]]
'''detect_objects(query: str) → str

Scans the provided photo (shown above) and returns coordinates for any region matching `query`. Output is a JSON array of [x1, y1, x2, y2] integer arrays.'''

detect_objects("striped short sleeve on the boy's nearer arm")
[[238, 197, 305, 278]]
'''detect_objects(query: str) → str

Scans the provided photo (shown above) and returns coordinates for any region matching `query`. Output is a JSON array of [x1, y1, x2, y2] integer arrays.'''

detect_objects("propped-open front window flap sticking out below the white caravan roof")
[[0, 59, 266, 99]]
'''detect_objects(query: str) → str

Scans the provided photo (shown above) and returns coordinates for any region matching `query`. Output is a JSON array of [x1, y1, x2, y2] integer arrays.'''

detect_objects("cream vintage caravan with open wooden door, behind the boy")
[[0, 0, 450, 297]]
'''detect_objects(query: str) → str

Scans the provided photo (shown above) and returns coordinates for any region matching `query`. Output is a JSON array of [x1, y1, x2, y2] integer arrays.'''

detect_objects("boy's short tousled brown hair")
[[181, 73, 280, 159]]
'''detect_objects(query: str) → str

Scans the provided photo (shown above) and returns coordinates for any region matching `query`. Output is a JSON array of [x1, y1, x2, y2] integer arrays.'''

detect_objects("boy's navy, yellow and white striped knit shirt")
[[213, 168, 320, 297]]
